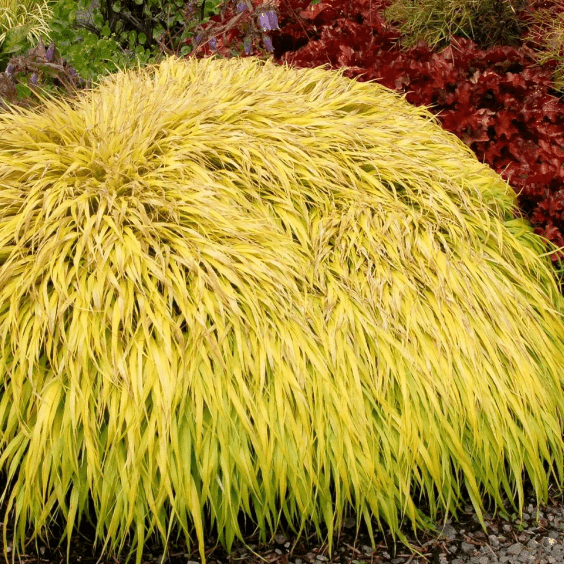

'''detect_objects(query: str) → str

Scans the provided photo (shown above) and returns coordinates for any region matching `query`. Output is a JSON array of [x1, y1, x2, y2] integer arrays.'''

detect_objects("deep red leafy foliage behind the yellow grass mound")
[[192, 0, 564, 278]]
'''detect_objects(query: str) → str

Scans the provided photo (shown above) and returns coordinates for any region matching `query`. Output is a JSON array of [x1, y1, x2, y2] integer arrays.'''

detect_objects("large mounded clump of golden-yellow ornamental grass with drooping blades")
[[0, 57, 564, 563]]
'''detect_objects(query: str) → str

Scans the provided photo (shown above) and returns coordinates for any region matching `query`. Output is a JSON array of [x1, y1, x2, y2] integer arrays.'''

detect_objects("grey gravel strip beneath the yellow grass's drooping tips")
[[204, 476, 564, 564]]
